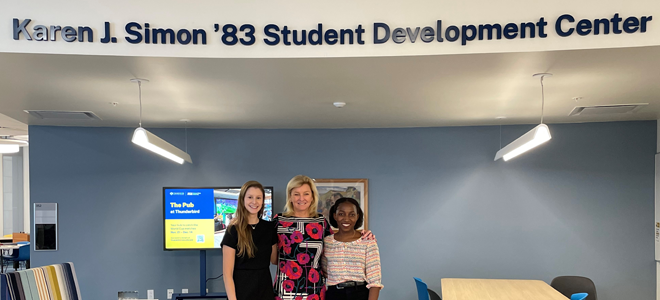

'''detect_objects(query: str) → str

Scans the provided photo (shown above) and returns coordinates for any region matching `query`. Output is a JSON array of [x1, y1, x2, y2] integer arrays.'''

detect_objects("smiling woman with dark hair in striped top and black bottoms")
[[322, 198, 383, 300]]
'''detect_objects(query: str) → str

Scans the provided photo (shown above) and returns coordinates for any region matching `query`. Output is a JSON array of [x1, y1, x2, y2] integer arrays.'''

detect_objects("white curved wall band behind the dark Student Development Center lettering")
[[0, 0, 660, 57]]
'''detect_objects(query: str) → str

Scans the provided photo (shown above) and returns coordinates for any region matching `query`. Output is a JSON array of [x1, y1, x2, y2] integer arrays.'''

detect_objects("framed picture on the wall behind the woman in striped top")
[[314, 178, 369, 232]]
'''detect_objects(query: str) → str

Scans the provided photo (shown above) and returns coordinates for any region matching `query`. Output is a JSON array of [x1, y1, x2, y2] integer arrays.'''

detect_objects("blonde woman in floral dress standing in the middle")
[[271, 175, 373, 300]]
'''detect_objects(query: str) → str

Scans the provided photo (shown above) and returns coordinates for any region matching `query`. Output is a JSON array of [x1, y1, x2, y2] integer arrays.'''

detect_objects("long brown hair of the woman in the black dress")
[[227, 180, 266, 258]]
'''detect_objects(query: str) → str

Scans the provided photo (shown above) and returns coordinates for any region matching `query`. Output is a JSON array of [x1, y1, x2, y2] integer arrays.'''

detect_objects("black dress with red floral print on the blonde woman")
[[275, 214, 332, 300]]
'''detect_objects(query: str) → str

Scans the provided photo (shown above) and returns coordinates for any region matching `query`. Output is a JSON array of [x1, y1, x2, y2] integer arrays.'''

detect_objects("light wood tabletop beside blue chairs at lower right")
[[440, 278, 568, 300]]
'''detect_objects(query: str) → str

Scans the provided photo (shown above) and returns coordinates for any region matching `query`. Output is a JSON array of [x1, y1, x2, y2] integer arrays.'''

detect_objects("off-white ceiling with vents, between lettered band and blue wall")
[[0, 47, 660, 128]]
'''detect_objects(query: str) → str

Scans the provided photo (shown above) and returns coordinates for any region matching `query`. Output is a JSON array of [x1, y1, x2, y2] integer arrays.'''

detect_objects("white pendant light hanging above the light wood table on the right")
[[494, 73, 552, 161]]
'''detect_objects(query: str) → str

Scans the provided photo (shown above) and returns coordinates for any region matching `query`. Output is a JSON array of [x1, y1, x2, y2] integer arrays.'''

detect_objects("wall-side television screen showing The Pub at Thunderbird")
[[163, 187, 273, 250]]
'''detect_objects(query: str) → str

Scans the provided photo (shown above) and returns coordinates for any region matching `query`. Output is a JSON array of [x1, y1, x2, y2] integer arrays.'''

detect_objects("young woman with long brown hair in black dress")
[[221, 181, 278, 300]]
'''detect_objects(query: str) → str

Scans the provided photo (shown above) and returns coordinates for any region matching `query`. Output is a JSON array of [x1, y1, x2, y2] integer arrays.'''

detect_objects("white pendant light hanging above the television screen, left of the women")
[[131, 78, 192, 164]]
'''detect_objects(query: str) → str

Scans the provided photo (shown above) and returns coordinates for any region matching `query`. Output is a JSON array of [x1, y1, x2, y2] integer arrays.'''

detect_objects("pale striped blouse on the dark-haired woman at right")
[[321, 235, 383, 288]]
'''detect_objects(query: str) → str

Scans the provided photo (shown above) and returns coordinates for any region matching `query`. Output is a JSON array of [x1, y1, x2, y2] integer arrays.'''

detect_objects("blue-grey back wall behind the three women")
[[30, 122, 656, 300]]
